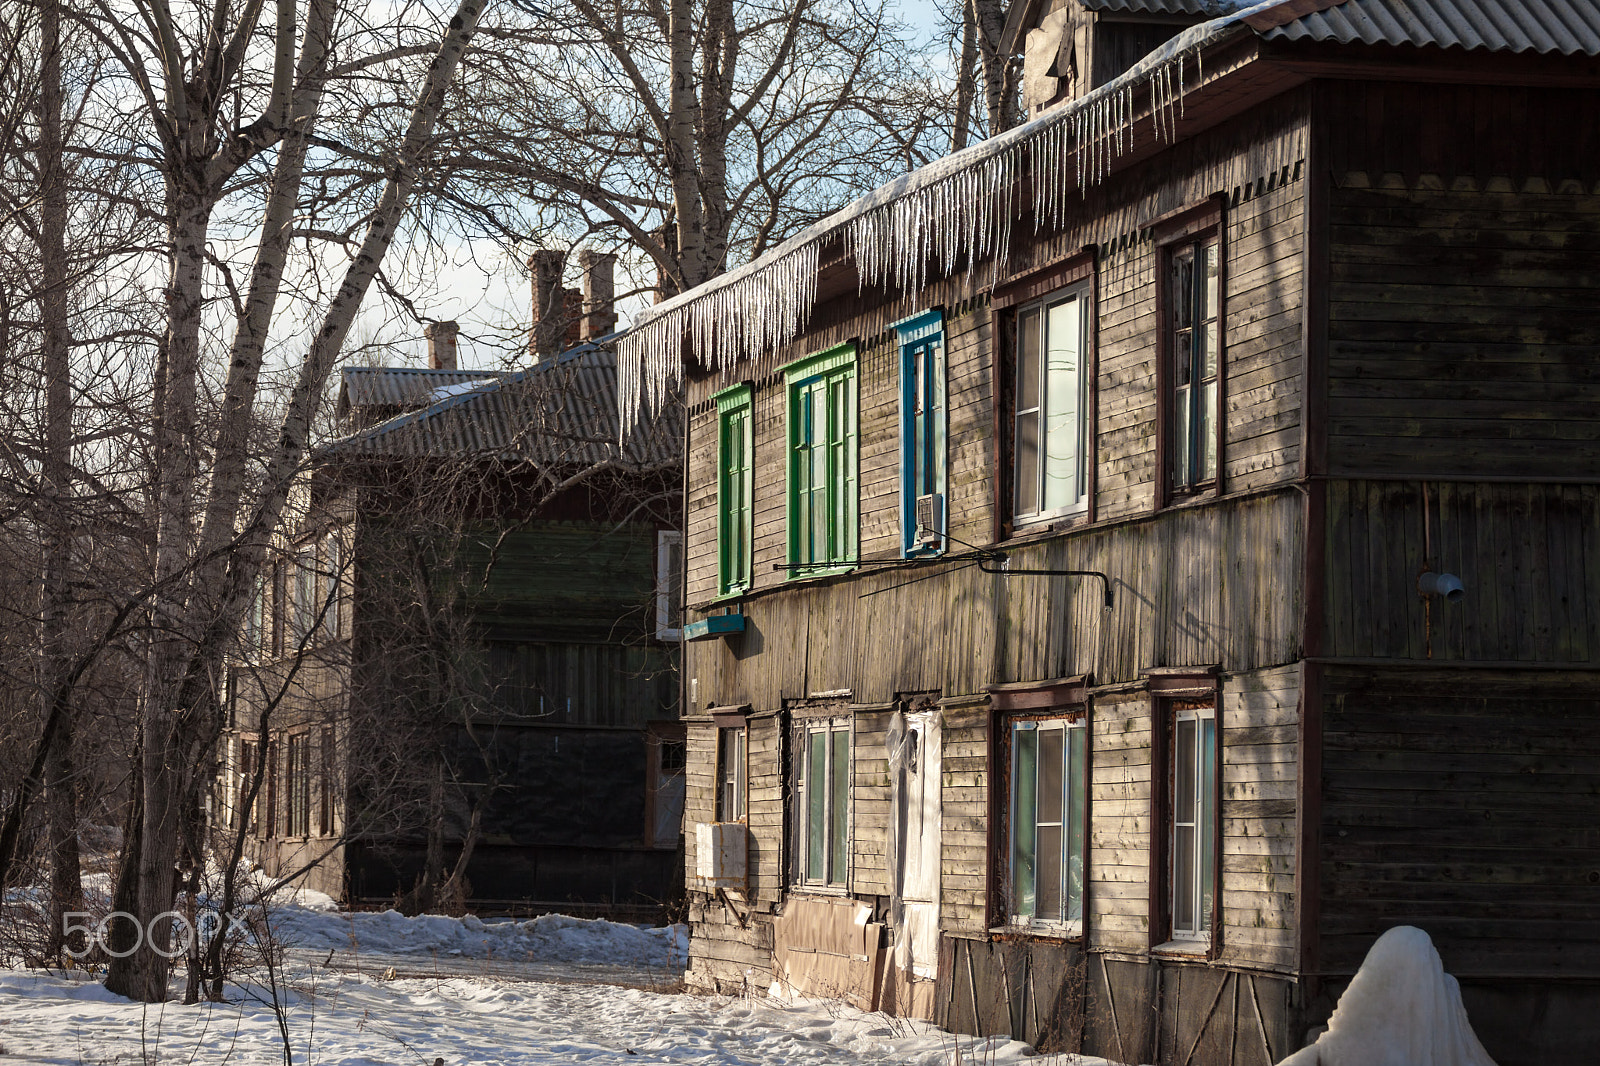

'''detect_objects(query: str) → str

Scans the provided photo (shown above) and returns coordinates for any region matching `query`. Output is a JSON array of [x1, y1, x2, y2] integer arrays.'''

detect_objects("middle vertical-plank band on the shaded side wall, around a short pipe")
[[1323, 476, 1600, 664]]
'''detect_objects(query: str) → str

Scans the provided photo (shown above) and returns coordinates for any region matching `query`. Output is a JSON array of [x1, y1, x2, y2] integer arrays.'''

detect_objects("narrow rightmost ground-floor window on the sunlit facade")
[[1171, 704, 1216, 940]]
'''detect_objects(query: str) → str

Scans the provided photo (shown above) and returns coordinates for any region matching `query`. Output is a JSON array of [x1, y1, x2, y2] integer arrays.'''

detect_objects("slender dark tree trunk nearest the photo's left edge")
[[38, 0, 83, 956]]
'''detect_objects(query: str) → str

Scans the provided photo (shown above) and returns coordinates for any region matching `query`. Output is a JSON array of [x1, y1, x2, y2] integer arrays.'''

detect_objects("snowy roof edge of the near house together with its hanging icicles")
[[618, 0, 1304, 431]]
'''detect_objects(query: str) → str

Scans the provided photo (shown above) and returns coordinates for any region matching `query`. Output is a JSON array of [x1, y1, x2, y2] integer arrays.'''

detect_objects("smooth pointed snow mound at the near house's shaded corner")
[[1278, 925, 1494, 1066]]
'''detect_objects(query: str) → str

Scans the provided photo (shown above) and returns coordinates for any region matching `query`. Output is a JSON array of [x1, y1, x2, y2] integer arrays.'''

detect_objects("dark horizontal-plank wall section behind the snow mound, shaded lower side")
[[1322, 667, 1600, 978]]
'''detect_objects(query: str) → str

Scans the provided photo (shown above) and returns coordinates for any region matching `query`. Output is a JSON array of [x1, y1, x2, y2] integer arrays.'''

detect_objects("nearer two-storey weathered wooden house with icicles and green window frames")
[[619, 0, 1600, 1066]]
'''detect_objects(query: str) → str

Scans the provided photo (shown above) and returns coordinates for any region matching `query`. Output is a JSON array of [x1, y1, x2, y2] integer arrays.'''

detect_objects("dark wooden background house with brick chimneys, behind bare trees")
[[222, 305, 683, 916]]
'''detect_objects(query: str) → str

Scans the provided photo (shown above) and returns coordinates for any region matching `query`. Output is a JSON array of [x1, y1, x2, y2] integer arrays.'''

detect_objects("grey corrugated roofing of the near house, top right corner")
[[1262, 0, 1600, 56]]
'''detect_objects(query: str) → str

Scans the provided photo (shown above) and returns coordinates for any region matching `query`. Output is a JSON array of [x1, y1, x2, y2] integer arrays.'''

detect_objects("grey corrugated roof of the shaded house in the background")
[[323, 344, 683, 467]]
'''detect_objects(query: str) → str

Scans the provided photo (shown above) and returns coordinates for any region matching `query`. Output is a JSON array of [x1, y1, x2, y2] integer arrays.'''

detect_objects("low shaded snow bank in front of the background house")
[[267, 892, 688, 970]]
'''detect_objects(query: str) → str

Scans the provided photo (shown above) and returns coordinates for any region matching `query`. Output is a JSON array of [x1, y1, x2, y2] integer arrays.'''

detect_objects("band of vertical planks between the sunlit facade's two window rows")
[[688, 491, 1304, 709]]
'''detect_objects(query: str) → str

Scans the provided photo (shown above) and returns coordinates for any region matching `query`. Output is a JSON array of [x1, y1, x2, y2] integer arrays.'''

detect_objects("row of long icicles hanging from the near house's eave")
[[618, 48, 1200, 434]]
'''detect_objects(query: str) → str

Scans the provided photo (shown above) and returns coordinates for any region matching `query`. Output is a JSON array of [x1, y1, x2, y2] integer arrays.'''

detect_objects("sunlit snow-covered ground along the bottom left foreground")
[[0, 970, 1049, 1066]]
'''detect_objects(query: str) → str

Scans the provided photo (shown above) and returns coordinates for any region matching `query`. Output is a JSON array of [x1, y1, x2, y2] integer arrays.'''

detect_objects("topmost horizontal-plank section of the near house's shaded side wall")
[[1326, 180, 1600, 480]]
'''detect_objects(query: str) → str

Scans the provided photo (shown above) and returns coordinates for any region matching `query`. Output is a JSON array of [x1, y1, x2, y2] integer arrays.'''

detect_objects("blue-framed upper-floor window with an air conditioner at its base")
[[894, 311, 947, 555]]
